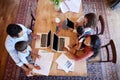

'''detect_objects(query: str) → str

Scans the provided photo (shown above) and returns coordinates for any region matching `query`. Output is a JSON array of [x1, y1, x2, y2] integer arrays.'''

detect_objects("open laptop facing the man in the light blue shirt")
[[35, 31, 51, 48]]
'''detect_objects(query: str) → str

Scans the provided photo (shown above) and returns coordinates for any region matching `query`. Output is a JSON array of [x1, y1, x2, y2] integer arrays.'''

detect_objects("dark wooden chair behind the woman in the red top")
[[88, 40, 117, 64]]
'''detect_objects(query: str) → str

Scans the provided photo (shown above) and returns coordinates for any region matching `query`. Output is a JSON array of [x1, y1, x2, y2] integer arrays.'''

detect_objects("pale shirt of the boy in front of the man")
[[18, 46, 31, 64]]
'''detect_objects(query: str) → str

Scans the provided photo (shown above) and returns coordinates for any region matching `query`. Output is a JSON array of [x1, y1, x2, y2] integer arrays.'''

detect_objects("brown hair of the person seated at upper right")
[[84, 13, 97, 29]]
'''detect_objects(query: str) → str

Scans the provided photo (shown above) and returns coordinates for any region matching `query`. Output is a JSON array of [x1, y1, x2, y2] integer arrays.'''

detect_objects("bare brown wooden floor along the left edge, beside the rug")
[[0, 0, 20, 80]]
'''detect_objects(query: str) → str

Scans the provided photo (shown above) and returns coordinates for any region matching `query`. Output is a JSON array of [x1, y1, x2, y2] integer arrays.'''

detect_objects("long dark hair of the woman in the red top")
[[91, 35, 101, 57]]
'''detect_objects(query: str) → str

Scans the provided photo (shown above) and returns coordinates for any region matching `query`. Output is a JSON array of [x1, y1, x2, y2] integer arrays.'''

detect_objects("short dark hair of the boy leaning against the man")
[[15, 41, 28, 51]]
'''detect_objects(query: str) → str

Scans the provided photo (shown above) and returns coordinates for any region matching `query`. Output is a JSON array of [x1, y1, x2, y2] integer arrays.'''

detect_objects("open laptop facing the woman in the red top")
[[52, 34, 70, 52]]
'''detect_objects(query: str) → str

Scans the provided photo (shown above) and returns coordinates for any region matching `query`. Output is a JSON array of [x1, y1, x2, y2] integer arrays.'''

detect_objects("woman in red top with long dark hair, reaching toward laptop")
[[64, 35, 101, 60]]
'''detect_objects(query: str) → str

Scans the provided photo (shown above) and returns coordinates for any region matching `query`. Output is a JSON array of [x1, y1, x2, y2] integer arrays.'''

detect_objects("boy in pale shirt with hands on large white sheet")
[[15, 41, 40, 74]]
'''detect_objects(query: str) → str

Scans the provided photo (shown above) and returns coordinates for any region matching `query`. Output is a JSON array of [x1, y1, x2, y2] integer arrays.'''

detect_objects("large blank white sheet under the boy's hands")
[[33, 50, 54, 76]]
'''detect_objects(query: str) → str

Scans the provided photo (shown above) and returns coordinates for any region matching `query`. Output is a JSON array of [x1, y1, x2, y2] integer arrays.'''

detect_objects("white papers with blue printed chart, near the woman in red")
[[56, 54, 74, 73]]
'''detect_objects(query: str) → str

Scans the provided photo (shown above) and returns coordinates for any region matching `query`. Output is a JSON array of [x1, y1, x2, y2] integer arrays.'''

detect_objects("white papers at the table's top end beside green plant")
[[60, 0, 81, 13]]
